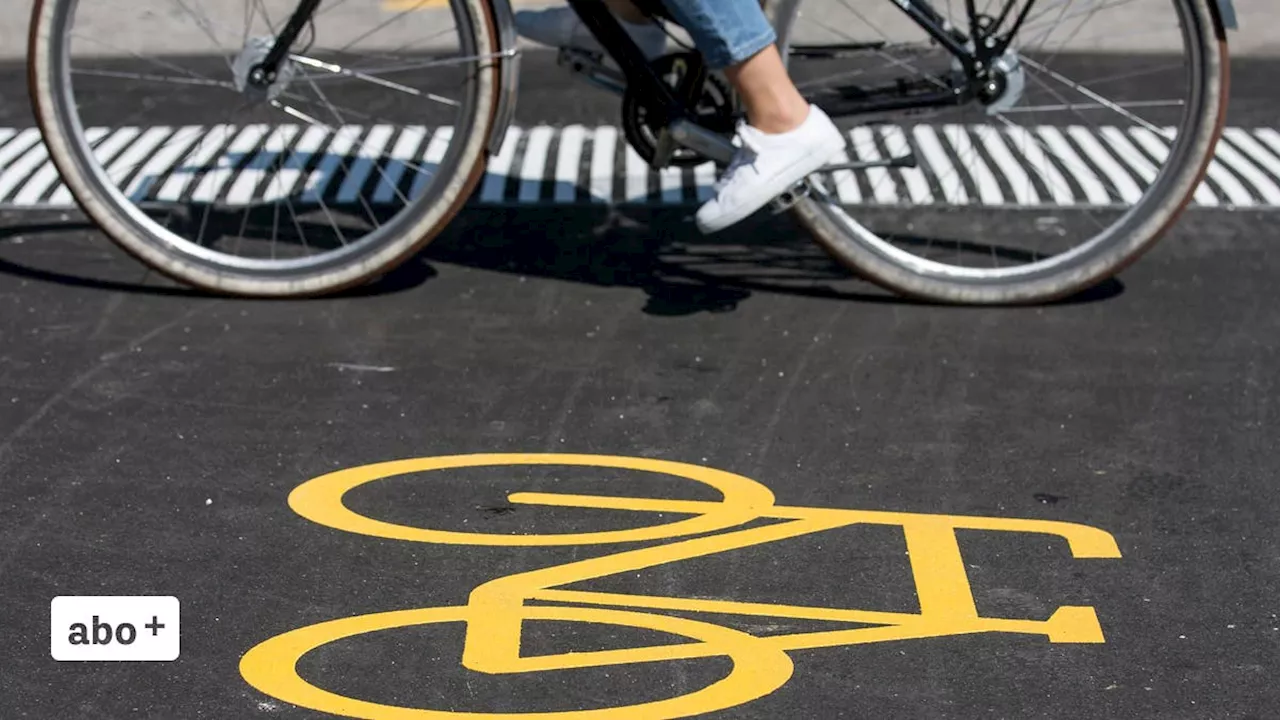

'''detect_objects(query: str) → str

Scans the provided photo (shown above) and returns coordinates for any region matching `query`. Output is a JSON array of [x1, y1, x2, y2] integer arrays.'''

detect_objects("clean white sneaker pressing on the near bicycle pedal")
[[698, 105, 845, 233]]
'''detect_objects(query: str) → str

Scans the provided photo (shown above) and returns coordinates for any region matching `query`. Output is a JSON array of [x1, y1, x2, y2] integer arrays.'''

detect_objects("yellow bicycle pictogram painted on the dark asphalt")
[[239, 454, 1120, 720]]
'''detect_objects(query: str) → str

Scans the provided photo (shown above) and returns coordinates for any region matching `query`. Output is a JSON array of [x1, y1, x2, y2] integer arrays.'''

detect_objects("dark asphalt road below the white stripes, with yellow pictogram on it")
[[0, 9, 1280, 720]]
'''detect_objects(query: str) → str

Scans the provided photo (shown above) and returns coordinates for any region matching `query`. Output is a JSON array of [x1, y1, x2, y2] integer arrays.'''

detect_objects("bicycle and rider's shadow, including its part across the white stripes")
[[0, 139, 1123, 310]]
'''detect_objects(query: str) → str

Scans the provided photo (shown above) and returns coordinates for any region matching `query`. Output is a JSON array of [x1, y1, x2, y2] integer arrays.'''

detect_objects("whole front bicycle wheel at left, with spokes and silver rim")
[[29, 0, 499, 296]]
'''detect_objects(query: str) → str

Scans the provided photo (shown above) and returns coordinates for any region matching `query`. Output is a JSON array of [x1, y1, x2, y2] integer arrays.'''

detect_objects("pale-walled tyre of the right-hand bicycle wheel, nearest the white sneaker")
[[765, 0, 1230, 305]]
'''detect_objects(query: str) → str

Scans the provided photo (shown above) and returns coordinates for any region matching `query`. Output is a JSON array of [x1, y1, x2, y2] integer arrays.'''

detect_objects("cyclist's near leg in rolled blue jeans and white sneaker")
[[650, 0, 845, 232]]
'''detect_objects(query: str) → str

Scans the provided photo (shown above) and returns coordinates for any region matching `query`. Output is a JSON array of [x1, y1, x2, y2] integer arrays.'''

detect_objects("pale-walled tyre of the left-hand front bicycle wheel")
[[28, 0, 503, 297]]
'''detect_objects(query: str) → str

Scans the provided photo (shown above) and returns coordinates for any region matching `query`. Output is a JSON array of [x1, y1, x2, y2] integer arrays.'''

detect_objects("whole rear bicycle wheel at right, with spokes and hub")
[[768, 0, 1228, 304]]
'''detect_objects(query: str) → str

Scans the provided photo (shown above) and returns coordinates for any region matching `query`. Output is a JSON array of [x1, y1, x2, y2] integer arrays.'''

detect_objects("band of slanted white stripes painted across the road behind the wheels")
[[0, 124, 1280, 209]]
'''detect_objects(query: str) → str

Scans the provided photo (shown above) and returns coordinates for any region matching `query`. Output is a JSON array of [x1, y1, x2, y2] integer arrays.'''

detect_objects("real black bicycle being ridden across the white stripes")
[[29, 0, 1235, 304]]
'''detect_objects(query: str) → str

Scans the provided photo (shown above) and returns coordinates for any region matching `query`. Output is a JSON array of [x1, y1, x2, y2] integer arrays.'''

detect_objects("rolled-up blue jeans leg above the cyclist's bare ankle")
[[662, 0, 778, 70]]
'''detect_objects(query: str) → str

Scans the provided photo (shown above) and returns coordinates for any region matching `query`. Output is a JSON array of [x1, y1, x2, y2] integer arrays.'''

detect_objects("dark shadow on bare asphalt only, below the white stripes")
[[0, 206, 1124, 315]]
